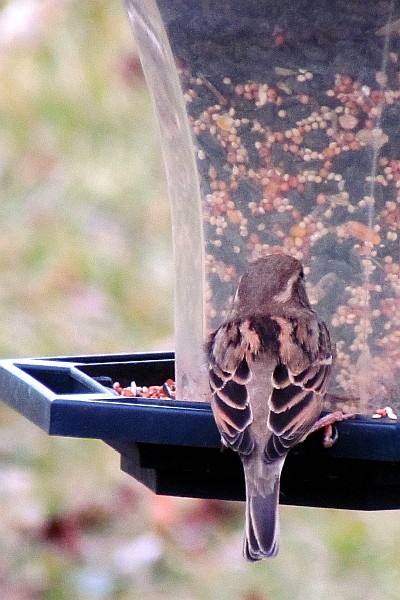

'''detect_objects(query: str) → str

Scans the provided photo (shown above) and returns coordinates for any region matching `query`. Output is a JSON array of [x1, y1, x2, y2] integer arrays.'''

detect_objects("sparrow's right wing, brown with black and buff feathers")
[[265, 318, 333, 462]]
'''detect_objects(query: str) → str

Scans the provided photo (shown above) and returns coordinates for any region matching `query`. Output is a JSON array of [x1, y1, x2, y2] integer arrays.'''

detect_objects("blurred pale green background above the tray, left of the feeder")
[[0, 0, 173, 356]]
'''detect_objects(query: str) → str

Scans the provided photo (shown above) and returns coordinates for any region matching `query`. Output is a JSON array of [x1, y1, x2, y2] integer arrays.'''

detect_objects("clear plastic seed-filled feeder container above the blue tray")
[[126, 0, 400, 413]]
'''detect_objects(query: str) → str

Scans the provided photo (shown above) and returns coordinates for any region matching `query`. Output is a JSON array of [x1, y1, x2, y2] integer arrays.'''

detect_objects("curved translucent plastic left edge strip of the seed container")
[[126, 0, 208, 400]]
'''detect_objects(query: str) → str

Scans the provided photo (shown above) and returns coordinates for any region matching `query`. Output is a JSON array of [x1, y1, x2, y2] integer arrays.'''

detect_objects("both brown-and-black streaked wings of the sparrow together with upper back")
[[207, 316, 332, 462]]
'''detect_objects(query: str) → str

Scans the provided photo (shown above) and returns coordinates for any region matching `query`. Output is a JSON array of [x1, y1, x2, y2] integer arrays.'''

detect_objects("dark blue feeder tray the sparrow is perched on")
[[0, 352, 400, 510]]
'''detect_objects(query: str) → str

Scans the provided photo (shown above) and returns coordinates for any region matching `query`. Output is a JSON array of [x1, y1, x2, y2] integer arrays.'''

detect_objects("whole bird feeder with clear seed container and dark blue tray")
[[0, 0, 400, 509]]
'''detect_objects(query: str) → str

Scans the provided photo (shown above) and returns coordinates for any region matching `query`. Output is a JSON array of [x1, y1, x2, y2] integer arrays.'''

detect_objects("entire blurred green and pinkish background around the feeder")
[[0, 0, 400, 600]]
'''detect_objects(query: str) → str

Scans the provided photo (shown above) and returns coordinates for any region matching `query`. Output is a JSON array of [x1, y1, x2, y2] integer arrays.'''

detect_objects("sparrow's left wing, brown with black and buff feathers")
[[207, 319, 268, 454]]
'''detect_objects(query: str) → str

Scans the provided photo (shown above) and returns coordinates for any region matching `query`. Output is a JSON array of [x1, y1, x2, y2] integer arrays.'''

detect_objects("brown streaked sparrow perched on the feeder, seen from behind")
[[206, 254, 334, 561]]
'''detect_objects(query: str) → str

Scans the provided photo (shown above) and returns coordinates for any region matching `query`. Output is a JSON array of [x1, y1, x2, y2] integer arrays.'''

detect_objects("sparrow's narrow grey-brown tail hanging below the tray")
[[243, 462, 279, 562]]
